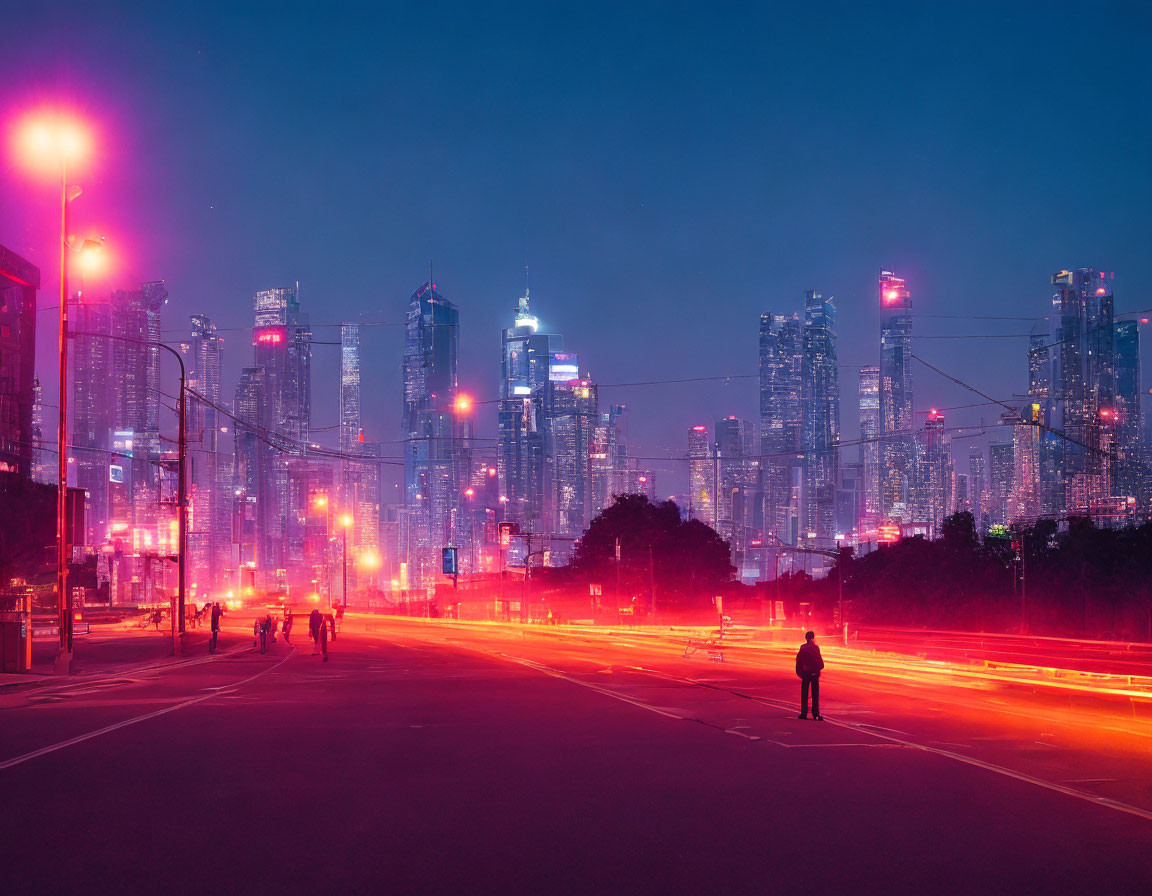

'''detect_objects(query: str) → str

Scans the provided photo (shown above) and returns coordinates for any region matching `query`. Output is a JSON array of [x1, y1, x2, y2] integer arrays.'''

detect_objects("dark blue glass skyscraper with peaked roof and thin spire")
[[403, 281, 471, 589]]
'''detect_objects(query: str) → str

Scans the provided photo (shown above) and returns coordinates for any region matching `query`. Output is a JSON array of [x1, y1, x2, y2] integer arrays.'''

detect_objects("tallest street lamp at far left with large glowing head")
[[17, 112, 91, 675]]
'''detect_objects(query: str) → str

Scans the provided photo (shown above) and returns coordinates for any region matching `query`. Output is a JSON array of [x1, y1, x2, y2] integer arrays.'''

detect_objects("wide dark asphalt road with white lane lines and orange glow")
[[0, 620, 1152, 894]]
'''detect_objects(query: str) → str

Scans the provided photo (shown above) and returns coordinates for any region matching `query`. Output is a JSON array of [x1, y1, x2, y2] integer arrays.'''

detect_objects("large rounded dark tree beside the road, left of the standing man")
[[569, 495, 735, 605]]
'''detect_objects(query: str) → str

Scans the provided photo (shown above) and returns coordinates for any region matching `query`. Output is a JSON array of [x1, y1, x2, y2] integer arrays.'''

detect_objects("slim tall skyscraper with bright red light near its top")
[[879, 271, 912, 522]]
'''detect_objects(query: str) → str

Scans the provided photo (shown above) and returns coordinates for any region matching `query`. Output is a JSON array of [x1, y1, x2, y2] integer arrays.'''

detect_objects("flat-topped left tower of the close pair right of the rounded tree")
[[760, 313, 804, 548]]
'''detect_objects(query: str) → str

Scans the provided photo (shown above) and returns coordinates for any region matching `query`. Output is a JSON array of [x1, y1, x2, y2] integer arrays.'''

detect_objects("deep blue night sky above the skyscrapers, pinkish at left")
[[0, 0, 1152, 494]]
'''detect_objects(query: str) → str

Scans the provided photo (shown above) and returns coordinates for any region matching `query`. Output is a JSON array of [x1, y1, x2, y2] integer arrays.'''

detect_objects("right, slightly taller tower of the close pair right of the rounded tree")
[[801, 290, 840, 549]]
